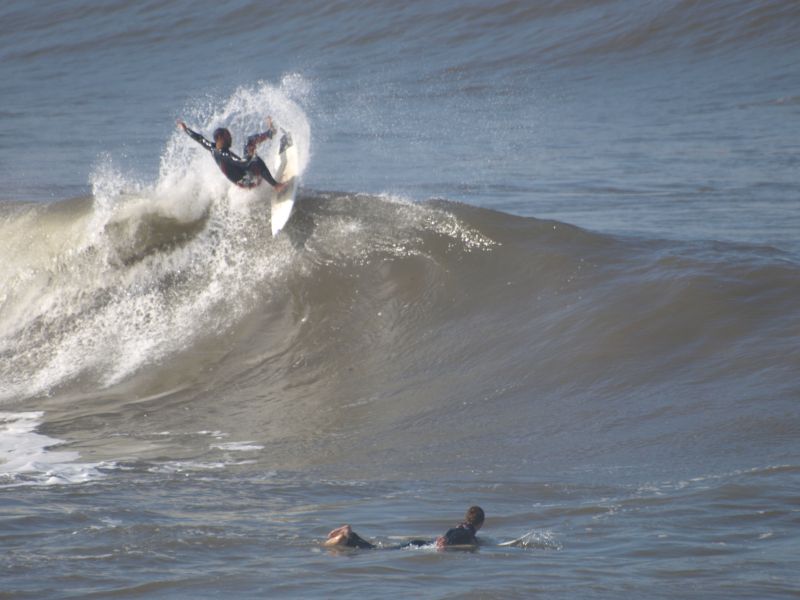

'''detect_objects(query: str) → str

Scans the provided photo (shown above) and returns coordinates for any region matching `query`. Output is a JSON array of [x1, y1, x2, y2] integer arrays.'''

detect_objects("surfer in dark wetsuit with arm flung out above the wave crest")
[[178, 118, 286, 193]]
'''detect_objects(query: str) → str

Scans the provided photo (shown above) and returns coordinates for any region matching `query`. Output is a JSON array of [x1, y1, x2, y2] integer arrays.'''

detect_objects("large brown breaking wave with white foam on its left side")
[[0, 180, 800, 477]]
